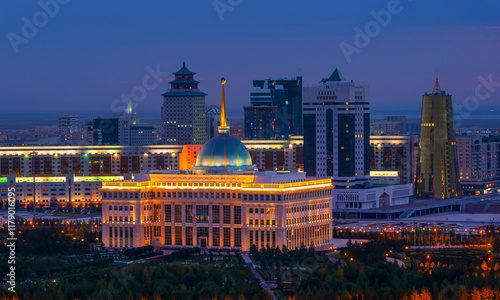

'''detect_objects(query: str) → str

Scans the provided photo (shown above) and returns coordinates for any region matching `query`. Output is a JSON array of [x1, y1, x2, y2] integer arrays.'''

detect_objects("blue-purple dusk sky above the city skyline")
[[0, 0, 500, 118]]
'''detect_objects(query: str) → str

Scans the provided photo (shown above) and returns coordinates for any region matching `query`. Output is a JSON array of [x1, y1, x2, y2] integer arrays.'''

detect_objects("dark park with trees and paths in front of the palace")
[[4, 219, 500, 300]]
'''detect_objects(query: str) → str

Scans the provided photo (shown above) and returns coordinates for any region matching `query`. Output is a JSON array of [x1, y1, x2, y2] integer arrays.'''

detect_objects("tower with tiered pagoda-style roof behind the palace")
[[162, 62, 207, 145]]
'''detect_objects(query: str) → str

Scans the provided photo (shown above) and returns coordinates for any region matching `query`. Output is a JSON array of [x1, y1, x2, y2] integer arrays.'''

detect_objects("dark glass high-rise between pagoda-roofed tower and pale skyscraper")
[[244, 76, 302, 139]]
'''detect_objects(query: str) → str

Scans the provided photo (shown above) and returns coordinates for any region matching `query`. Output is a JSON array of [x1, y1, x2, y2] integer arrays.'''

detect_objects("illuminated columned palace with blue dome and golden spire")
[[101, 80, 333, 251]]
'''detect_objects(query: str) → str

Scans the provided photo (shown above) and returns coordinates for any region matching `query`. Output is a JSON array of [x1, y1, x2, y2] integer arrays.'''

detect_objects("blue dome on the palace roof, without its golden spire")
[[195, 134, 253, 170]]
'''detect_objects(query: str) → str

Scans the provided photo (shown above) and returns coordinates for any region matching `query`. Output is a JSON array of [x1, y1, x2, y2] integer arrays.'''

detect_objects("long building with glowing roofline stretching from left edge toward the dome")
[[0, 145, 183, 177]]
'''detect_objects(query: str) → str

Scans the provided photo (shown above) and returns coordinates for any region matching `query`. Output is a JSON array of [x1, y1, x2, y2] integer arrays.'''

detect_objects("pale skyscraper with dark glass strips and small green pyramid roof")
[[304, 69, 370, 188]]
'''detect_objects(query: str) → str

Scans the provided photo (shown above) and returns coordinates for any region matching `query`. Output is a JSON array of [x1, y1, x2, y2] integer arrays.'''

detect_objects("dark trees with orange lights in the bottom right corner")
[[287, 241, 500, 300]]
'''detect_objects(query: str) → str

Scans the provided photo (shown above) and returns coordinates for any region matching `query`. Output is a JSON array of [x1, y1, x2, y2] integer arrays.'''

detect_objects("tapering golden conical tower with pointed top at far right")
[[415, 74, 460, 199]]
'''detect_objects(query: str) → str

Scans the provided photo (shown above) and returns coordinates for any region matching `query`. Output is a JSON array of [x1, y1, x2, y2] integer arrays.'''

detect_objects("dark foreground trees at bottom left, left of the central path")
[[0, 262, 272, 300]]
